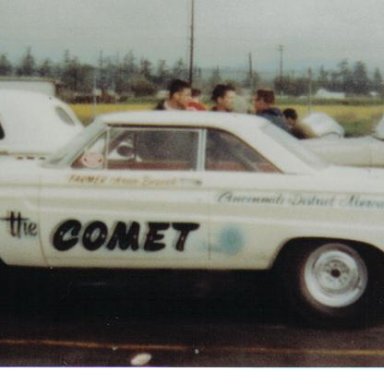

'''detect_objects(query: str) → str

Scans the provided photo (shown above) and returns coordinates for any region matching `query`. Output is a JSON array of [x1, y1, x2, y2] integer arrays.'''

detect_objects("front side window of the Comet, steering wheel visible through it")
[[73, 127, 198, 171]]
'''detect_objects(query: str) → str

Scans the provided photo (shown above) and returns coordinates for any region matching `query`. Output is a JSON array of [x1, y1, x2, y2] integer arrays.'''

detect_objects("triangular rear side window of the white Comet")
[[205, 130, 280, 173]]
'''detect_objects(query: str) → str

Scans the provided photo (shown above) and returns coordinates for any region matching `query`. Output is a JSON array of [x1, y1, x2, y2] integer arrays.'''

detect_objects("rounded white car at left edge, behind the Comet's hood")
[[0, 89, 84, 158]]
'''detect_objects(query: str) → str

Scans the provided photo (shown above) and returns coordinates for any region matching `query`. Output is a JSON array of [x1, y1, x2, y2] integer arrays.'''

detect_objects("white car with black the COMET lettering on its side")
[[0, 112, 384, 324]]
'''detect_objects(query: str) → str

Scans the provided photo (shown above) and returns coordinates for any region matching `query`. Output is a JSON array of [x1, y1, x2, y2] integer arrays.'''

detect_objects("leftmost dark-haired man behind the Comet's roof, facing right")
[[155, 79, 192, 111]]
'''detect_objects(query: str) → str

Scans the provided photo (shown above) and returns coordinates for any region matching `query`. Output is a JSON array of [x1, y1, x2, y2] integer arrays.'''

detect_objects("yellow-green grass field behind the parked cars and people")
[[71, 101, 384, 136]]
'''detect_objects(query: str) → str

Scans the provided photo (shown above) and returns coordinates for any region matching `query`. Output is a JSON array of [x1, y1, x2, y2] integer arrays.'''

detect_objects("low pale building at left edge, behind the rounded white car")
[[0, 76, 59, 96]]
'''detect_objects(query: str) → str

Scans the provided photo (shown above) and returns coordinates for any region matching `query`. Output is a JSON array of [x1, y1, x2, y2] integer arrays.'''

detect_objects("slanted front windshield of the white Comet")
[[44, 122, 105, 167]]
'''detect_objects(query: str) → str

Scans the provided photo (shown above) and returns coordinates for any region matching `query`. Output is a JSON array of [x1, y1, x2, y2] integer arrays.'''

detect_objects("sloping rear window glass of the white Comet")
[[261, 124, 328, 170]]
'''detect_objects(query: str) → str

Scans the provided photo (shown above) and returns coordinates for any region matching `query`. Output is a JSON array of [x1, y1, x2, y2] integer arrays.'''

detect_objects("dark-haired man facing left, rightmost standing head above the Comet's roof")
[[254, 89, 290, 132]]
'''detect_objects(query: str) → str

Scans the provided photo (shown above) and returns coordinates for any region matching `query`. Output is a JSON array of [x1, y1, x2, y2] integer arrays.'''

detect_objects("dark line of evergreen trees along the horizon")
[[0, 48, 384, 99]]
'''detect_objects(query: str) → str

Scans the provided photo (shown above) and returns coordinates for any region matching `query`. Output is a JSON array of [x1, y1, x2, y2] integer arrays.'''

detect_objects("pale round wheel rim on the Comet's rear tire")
[[304, 244, 368, 308]]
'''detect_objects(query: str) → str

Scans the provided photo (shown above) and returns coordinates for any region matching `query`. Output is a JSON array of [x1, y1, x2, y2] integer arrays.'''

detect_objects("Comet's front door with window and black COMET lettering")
[[40, 126, 208, 268]]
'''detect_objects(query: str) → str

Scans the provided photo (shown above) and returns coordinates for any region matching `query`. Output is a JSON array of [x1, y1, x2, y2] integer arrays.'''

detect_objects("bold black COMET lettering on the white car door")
[[52, 219, 200, 252]]
